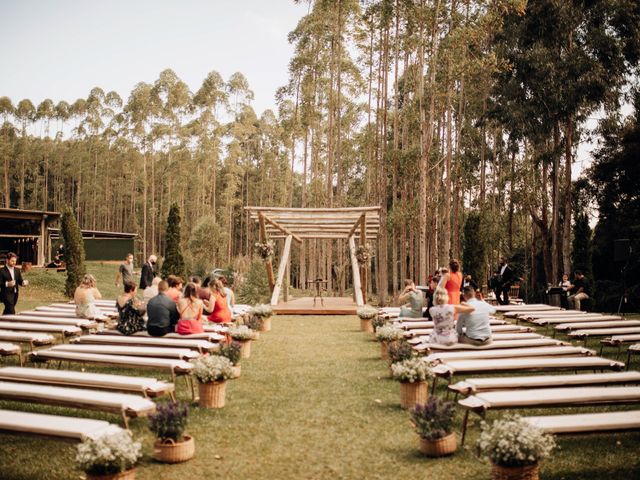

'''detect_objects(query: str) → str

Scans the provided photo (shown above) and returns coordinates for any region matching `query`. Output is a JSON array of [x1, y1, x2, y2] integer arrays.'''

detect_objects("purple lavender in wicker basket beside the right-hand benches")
[[411, 396, 458, 457]]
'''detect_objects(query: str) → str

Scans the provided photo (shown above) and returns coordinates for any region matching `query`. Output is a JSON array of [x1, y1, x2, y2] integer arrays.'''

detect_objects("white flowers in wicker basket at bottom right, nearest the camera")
[[478, 416, 556, 480]]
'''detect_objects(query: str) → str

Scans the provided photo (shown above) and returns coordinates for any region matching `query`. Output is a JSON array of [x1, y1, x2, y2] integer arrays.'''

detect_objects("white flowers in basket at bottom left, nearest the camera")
[[76, 429, 142, 480]]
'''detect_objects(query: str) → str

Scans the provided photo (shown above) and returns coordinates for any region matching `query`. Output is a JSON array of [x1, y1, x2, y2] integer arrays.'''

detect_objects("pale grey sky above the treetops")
[[0, 0, 308, 114]]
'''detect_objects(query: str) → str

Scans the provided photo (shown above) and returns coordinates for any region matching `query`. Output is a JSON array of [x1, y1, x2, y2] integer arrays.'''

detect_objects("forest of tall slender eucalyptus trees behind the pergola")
[[0, 0, 640, 308]]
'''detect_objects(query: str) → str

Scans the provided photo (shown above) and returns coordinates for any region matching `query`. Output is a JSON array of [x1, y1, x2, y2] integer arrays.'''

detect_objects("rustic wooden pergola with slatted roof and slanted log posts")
[[245, 207, 380, 306]]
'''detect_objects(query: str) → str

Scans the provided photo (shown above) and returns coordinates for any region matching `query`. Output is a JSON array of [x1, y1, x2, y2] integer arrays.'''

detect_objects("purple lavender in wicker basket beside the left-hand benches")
[[149, 402, 196, 463]]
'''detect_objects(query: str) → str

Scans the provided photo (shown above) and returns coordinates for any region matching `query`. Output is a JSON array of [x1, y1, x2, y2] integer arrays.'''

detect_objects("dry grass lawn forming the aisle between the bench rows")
[[0, 265, 640, 480]]
